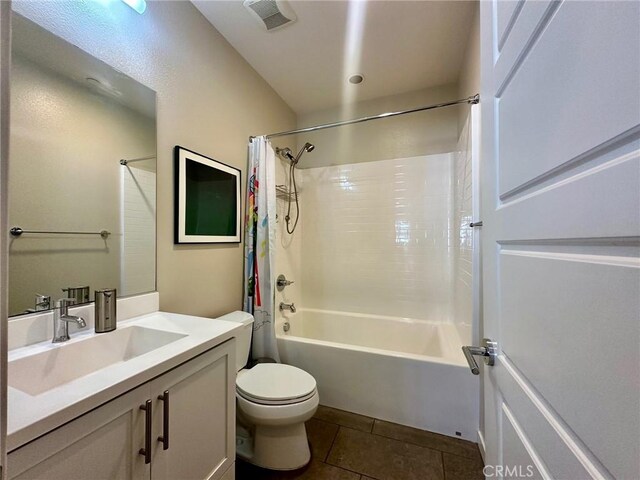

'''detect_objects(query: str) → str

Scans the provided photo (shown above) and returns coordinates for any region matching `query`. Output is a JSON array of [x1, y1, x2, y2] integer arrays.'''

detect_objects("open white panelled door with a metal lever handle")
[[481, 0, 640, 480]]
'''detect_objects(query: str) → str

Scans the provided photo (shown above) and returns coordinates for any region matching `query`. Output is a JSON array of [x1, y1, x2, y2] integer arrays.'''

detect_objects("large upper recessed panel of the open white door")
[[496, 2, 640, 196]]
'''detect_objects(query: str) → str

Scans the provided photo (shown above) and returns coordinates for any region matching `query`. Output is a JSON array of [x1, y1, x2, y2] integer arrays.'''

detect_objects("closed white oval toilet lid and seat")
[[236, 363, 316, 402]]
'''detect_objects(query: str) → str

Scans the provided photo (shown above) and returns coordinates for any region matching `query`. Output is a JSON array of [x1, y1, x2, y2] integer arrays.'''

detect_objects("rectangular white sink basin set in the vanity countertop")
[[8, 325, 186, 395]]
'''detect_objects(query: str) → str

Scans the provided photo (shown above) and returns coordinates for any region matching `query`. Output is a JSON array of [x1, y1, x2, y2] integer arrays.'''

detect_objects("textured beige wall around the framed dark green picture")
[[14, 1, 295, 316]]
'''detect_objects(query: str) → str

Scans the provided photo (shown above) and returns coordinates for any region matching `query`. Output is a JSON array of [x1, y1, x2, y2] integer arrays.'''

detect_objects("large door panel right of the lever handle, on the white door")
[[499, 246, 640, 474]]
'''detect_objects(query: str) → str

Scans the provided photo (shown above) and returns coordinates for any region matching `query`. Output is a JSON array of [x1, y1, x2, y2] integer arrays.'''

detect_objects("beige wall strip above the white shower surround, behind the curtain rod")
[[292, 85, 465, 168]]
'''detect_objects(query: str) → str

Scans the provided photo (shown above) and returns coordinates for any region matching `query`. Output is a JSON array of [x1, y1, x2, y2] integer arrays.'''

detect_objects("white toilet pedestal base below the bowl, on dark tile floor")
[[237, 423, 311, 470]]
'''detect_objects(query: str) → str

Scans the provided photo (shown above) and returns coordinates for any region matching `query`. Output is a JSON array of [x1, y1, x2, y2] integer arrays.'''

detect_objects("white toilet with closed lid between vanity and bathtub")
[[219, 311, 319, 470]]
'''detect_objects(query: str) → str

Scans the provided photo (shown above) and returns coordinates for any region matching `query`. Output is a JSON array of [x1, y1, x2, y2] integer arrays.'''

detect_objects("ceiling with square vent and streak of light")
[[192, 0, 476, 114]]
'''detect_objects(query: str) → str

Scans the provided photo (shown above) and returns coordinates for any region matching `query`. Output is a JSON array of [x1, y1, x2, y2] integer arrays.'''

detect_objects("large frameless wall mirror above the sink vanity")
[[9, 13, 156, 315]]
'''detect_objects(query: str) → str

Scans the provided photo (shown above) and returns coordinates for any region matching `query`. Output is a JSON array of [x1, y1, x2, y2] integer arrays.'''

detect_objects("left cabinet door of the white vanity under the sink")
[[7, 385, 151, 480]]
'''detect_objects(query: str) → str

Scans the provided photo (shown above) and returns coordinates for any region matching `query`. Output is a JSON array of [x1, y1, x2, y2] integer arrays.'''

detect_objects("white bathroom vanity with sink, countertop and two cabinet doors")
[[7, 294, 239, 480]]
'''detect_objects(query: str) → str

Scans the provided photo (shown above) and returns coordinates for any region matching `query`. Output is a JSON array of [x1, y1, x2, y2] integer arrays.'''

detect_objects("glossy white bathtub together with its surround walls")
[[276, 117, 480, 441]]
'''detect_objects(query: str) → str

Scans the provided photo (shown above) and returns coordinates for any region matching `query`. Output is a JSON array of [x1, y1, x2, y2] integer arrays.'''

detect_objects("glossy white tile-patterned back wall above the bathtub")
[[301, 154, 453, 321]]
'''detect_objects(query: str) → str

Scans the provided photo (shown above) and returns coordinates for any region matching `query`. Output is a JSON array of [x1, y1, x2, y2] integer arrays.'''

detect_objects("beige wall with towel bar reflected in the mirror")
[[9, 55, 156, 315]]
